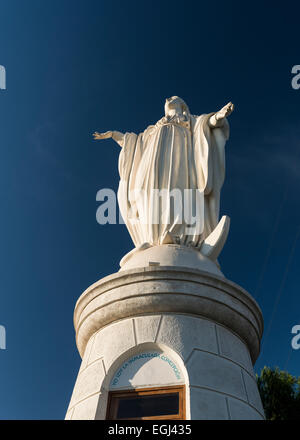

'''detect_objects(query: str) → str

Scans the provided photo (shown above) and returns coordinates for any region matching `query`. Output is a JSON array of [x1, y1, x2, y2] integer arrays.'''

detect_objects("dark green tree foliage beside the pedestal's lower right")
[[256, 367, 300, 420]]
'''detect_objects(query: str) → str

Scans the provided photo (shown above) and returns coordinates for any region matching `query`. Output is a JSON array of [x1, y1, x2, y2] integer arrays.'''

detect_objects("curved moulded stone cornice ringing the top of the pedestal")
[[74, 266, 263, 363]]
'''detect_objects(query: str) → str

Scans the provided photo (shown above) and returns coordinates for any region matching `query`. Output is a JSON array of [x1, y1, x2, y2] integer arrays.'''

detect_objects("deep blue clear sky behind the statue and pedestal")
[[0, 0, 300, 419]]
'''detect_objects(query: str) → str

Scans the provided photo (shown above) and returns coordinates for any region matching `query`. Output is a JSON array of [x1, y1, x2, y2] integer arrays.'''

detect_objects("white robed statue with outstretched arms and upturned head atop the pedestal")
[[94, 96, 234, 260]]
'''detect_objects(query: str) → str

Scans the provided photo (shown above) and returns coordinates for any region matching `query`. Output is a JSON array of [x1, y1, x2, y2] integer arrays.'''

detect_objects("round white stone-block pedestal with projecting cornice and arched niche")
[[66, 266, 264, 420]]
